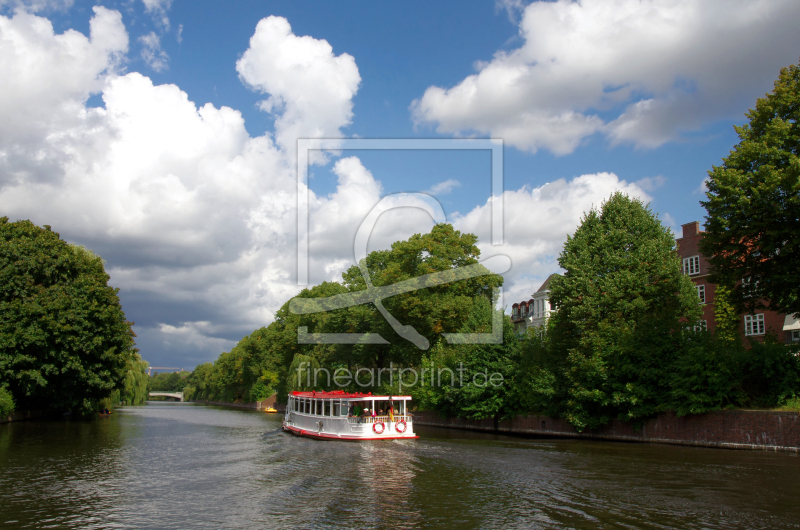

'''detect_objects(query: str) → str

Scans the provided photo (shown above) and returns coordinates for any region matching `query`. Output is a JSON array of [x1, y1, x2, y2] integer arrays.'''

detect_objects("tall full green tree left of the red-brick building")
[[550, 193, 700, 430]]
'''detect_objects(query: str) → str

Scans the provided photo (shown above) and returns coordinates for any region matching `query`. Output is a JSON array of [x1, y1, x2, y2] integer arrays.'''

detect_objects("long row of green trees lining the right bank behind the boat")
[[186, 58, 800, 430]]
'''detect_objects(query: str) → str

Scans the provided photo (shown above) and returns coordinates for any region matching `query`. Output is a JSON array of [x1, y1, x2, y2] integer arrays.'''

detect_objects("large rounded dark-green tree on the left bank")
[[0, 217, 136, 411]]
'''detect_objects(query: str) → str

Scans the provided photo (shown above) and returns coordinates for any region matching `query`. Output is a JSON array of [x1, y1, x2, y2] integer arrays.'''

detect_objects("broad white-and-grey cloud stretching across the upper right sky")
[[411, 0, 800, 155]]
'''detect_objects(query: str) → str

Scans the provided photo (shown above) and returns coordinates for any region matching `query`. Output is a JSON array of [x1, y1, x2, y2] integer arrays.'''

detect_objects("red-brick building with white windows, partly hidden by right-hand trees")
[[676, 221, 800, 342]]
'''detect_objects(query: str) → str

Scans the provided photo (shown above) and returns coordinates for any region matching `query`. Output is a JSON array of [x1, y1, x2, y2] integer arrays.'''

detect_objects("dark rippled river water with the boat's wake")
[[0, 403, 800, 530]]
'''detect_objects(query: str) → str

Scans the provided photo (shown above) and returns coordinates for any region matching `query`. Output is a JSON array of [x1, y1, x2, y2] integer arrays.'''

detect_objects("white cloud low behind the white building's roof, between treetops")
[[454, 173, 652, 307]]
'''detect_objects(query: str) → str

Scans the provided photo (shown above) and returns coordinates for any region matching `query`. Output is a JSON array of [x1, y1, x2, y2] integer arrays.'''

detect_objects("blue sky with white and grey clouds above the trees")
[[0, 0, 800, 369]]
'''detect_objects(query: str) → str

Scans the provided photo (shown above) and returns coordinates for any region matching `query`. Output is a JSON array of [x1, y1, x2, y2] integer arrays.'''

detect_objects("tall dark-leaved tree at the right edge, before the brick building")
[[701, 58, 800, 314]]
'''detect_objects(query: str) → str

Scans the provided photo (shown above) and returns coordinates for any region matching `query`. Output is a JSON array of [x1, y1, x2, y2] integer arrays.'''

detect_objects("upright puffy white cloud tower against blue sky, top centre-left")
[[236, 16, 361, 161]]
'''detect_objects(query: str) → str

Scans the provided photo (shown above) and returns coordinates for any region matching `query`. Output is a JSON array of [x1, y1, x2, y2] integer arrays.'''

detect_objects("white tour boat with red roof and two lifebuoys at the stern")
[[283, 390, 419, 440]]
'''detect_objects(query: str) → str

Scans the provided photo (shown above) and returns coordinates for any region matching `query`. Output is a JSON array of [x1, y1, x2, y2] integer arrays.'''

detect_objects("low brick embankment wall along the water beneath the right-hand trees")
[[414, 410, 800, 453]]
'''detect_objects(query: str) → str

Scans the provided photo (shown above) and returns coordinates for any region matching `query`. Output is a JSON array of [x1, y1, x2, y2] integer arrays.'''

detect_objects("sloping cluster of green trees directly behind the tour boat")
[[187, 224, 503, 401]]
